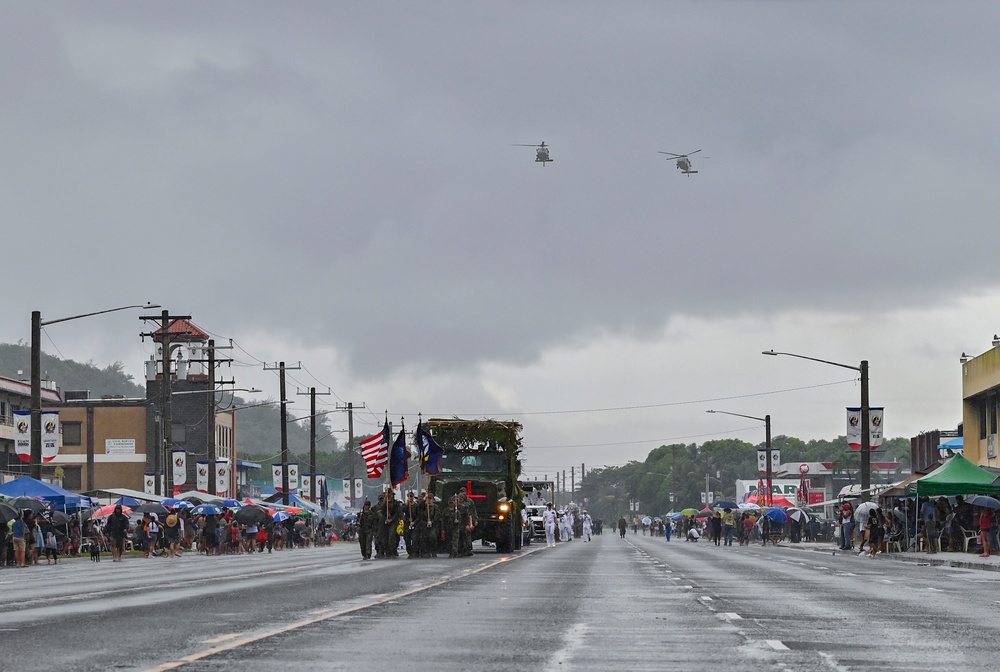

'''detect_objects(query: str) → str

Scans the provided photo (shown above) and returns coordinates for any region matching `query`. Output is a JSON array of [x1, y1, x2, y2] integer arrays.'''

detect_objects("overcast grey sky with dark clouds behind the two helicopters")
[[0, 0, 1000, 476]]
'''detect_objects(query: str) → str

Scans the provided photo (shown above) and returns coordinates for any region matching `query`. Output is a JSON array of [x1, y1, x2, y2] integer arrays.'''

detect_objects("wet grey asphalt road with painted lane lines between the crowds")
[[0, 534, 1000, 672]]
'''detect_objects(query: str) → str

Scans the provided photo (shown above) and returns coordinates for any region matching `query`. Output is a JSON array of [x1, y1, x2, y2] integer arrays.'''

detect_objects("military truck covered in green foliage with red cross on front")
[[424, 418, 524, 553]]
